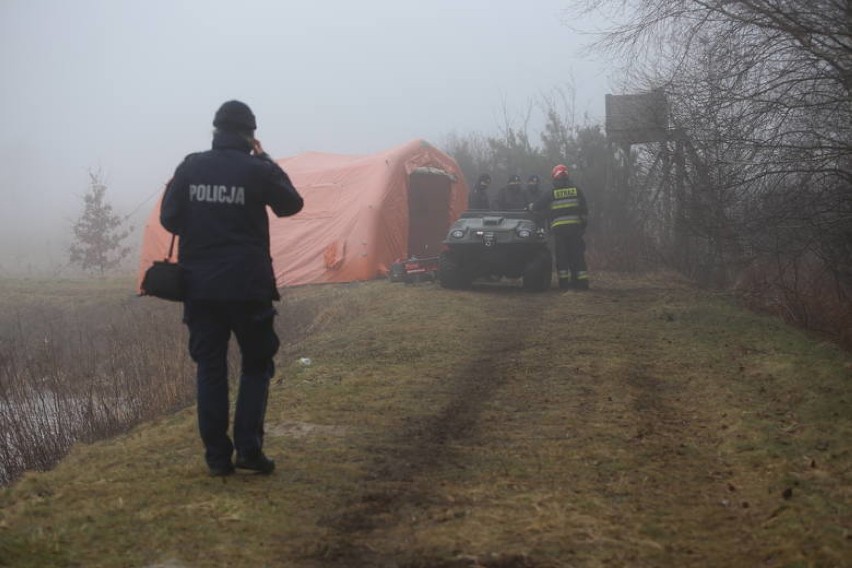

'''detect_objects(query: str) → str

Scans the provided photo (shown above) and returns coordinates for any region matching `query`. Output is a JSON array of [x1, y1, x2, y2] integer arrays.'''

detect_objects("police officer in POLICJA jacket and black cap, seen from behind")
[[160, 101, 303, 476]]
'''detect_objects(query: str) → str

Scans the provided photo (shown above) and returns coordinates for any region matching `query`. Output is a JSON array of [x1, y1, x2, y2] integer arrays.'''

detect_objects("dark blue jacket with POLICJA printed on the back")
[[160, 131, 303, 301]]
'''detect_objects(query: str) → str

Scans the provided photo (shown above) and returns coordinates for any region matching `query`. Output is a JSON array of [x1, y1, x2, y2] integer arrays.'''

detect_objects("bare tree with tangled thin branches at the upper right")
[[568, 0, 852, 338]]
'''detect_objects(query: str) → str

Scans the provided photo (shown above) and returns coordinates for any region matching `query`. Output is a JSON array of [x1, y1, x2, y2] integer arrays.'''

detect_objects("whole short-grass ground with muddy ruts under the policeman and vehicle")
[[0, 274, 852, 568]]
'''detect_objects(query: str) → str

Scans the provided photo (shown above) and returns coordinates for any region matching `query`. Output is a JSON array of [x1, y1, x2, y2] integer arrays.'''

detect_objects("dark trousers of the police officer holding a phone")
[[184, 300, 279, 467]]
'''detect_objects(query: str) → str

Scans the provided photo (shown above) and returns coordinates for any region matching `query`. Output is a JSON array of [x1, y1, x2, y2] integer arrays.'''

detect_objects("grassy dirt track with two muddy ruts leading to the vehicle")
[[276, 274, 848, 567]]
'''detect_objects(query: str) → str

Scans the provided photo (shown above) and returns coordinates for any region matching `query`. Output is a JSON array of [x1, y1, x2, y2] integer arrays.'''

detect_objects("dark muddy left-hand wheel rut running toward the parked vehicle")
[[315, 290, 554, 568]]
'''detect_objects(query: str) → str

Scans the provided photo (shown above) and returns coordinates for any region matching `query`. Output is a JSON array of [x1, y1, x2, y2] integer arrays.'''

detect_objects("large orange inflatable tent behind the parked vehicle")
[[139, 140, 468, 287]]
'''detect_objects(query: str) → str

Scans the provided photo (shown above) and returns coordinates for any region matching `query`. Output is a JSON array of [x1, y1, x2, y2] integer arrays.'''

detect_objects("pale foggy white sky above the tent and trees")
[[0, 0, 611, 274]]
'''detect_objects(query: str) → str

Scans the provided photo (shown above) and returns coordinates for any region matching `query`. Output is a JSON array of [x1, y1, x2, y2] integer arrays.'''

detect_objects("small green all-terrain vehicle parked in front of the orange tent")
[[438, 210, 553, 292]]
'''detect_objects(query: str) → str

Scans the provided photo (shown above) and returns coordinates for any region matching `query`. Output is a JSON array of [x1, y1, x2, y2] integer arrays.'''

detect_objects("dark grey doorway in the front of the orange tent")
[[408, 168, 452, 258]]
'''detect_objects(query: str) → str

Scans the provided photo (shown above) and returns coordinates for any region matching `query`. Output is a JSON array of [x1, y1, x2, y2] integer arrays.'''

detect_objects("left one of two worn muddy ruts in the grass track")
[[308, 290, 549, 568]]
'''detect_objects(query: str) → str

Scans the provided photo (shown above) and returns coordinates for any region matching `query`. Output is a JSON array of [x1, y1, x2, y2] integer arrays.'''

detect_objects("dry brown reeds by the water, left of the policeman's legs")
[[0, 279, 194, 484]]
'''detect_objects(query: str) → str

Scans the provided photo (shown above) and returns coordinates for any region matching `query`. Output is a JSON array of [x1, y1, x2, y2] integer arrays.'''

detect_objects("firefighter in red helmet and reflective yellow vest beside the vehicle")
[[530, 164, 589, 290]]
